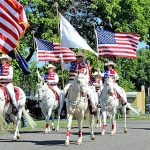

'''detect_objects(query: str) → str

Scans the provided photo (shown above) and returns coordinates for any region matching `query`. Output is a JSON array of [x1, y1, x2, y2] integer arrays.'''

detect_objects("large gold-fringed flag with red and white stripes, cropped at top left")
[[0, 0, 29, 54]]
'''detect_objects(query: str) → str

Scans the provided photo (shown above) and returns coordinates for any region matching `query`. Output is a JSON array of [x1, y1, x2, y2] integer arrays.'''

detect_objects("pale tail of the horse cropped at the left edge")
[[23, 108, 36, 129]]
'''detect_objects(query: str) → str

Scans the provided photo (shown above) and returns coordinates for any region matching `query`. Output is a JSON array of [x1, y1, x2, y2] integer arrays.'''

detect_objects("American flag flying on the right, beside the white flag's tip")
[[96, 29, 140, 58]]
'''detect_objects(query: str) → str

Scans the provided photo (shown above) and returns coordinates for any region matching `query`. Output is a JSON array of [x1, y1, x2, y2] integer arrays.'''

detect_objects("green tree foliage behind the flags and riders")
[[9, 0, 150, 94]]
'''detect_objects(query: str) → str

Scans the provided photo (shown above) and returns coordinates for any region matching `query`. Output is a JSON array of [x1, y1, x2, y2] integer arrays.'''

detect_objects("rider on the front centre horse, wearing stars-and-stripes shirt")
[[63, 52, 97, 113]]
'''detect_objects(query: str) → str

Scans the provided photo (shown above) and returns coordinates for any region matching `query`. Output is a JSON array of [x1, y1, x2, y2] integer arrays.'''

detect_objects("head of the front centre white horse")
[[75, 73, 88, 97]]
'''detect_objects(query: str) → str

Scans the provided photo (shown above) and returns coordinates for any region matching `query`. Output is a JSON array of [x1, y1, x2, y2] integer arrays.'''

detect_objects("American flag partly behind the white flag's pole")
[[35, 39, 76, 62]]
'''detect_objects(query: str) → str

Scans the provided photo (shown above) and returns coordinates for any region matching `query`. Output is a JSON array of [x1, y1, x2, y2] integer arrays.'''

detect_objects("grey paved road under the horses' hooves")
[[0, 120, 150, 150]]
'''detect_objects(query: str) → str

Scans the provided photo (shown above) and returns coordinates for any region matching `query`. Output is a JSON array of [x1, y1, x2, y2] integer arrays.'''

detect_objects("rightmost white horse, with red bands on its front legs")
[[100, 77, 128, 135]]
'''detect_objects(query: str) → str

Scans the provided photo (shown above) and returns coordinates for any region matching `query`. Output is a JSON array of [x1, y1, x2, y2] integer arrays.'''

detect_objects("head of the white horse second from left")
[[37, 81, 47, 100]]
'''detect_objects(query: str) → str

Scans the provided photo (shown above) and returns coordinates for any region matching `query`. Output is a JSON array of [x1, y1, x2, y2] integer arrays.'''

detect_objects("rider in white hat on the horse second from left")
[[37, 64, 64, 110]]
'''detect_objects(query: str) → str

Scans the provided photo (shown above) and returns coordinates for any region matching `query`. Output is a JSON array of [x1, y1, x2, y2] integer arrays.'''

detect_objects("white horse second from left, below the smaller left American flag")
[[37, 81, 61, 133]]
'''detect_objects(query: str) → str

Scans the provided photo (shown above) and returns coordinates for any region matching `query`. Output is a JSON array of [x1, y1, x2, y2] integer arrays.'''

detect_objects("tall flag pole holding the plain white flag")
[[54, 2, 65, 89]]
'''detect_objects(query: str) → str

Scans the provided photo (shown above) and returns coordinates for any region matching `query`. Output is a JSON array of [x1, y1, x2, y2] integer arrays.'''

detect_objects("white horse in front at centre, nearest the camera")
[[65, 73, 95, 145]]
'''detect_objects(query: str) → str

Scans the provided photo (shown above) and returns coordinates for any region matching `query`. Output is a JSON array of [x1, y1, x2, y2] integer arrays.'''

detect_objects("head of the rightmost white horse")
[[105, 77, 115, 95]]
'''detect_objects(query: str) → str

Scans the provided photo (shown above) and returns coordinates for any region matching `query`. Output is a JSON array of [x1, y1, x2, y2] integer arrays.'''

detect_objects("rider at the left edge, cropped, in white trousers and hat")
[[0, 54, 18, 113]]
